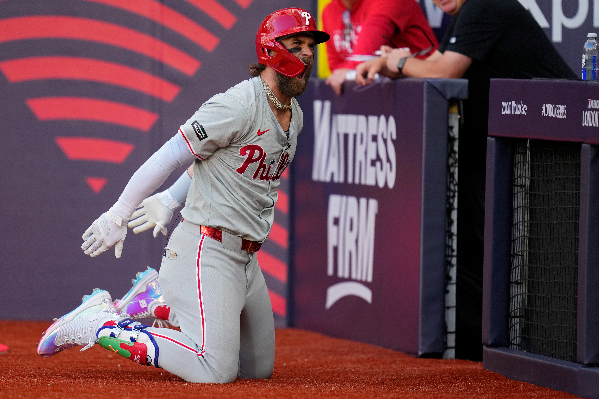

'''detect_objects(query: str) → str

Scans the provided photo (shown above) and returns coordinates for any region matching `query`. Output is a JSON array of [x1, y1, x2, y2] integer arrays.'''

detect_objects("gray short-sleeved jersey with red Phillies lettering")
[[180, 77, 303, 242]]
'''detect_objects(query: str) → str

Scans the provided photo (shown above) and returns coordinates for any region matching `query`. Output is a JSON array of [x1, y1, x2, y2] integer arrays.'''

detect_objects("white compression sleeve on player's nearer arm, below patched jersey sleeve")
[[111, 133, 196, 219]]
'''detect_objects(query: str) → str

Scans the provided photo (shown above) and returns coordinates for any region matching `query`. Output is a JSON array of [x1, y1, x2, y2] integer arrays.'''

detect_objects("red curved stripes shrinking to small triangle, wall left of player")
[[0, 0, 252, 194]]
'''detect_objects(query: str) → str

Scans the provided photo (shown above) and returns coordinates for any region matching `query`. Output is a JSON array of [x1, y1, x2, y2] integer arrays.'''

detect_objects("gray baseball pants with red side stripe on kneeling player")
[[146, 221, 275, 383]]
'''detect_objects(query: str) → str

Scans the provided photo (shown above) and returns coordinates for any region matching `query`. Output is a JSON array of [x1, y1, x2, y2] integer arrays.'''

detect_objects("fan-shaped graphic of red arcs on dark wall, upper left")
[[0, 0, 253, 193]]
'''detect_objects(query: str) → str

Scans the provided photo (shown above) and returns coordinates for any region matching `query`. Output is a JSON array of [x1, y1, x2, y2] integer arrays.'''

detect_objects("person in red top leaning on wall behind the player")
[[322, 0, 438, 94]]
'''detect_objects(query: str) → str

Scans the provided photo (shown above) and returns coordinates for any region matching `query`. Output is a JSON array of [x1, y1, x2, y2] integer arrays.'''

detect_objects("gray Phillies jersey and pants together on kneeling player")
[[143, 78, 302, 382]]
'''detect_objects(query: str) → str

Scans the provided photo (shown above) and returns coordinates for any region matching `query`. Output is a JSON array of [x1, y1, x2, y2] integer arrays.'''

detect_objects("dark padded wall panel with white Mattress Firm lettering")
[[291, 80, 466, 354]]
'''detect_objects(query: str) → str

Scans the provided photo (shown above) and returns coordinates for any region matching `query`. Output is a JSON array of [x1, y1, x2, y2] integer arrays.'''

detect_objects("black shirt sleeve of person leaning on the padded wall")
[[444, 1, 506, 61]]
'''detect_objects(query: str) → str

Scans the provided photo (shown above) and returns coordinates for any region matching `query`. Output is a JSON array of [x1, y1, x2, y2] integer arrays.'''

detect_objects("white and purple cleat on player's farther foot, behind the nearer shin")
[[115, 267, 170, 327]]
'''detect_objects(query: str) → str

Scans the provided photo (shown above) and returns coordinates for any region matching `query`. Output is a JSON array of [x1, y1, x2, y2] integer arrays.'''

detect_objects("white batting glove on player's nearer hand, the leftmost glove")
[[81, 210, 127, 258]]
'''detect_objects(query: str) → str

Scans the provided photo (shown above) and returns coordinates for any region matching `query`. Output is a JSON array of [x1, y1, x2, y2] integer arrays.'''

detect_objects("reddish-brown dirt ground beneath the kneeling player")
[[0, 321, 576, 399]]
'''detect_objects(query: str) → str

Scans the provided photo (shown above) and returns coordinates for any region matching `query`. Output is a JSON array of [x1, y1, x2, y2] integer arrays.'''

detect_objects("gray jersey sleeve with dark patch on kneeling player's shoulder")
[[179, 93, 249, 159]]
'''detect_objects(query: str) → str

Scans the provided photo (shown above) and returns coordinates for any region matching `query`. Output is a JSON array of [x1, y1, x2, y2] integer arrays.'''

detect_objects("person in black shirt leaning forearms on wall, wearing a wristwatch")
[[356, 0, 577, 360]]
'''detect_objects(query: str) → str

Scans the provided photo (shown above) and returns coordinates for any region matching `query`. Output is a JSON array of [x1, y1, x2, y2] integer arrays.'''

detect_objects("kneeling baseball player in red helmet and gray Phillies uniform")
[[38, 8, 329, 383]]
